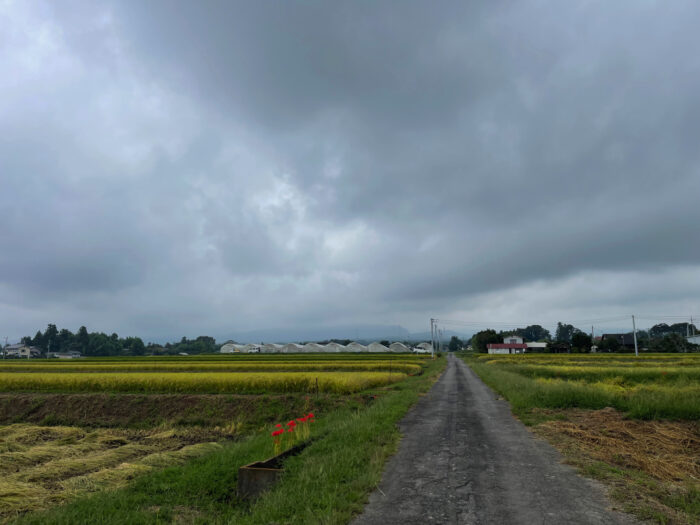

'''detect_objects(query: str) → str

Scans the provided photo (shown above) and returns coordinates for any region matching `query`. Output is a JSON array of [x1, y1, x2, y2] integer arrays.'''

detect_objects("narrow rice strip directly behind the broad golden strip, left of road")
[[0, 360, 422, 374]]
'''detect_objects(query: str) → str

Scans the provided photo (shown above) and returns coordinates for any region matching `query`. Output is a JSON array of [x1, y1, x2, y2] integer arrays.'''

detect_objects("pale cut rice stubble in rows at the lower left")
[[0, 424, 223, 519]]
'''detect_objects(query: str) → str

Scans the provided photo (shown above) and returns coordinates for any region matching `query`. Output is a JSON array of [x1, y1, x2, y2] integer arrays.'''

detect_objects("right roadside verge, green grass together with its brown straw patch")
[[462, 355, 700, 525]]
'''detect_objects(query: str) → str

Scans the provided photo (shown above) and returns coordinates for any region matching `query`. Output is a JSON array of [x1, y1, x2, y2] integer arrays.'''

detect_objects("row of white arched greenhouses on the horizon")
[[220, 342, 432, 354]]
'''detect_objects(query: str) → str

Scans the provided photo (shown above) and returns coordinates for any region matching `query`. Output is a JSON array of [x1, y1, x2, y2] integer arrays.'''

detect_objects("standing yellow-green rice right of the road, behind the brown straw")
[[467, 355, 700, 420]]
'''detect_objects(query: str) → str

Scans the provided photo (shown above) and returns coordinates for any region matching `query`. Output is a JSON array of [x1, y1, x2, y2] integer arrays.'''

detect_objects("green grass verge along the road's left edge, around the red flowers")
[[9, 358, 445, 524]]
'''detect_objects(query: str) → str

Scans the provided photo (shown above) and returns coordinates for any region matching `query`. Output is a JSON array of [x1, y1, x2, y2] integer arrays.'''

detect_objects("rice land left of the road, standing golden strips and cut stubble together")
[[0, 354, 437, 523]]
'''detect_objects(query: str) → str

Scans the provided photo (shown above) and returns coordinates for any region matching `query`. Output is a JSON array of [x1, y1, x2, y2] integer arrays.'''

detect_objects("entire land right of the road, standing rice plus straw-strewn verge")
[[465, 354, 700, 525]]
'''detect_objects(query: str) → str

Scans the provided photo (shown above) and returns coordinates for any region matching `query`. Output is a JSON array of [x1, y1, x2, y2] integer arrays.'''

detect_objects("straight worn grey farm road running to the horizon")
[[353, 355, 637, 525]]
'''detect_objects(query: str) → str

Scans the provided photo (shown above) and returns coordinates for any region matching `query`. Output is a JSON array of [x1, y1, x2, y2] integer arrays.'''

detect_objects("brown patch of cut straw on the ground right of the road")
[[532, 408, 700, 525]]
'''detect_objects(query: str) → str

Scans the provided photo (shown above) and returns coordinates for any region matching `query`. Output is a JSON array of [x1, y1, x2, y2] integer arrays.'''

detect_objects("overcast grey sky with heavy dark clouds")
[[0, 0, 700, 339]]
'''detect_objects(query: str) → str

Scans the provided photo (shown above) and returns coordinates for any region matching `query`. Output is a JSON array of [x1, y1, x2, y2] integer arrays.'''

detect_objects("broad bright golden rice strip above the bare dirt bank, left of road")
[[0, 372, 406, 394]]
